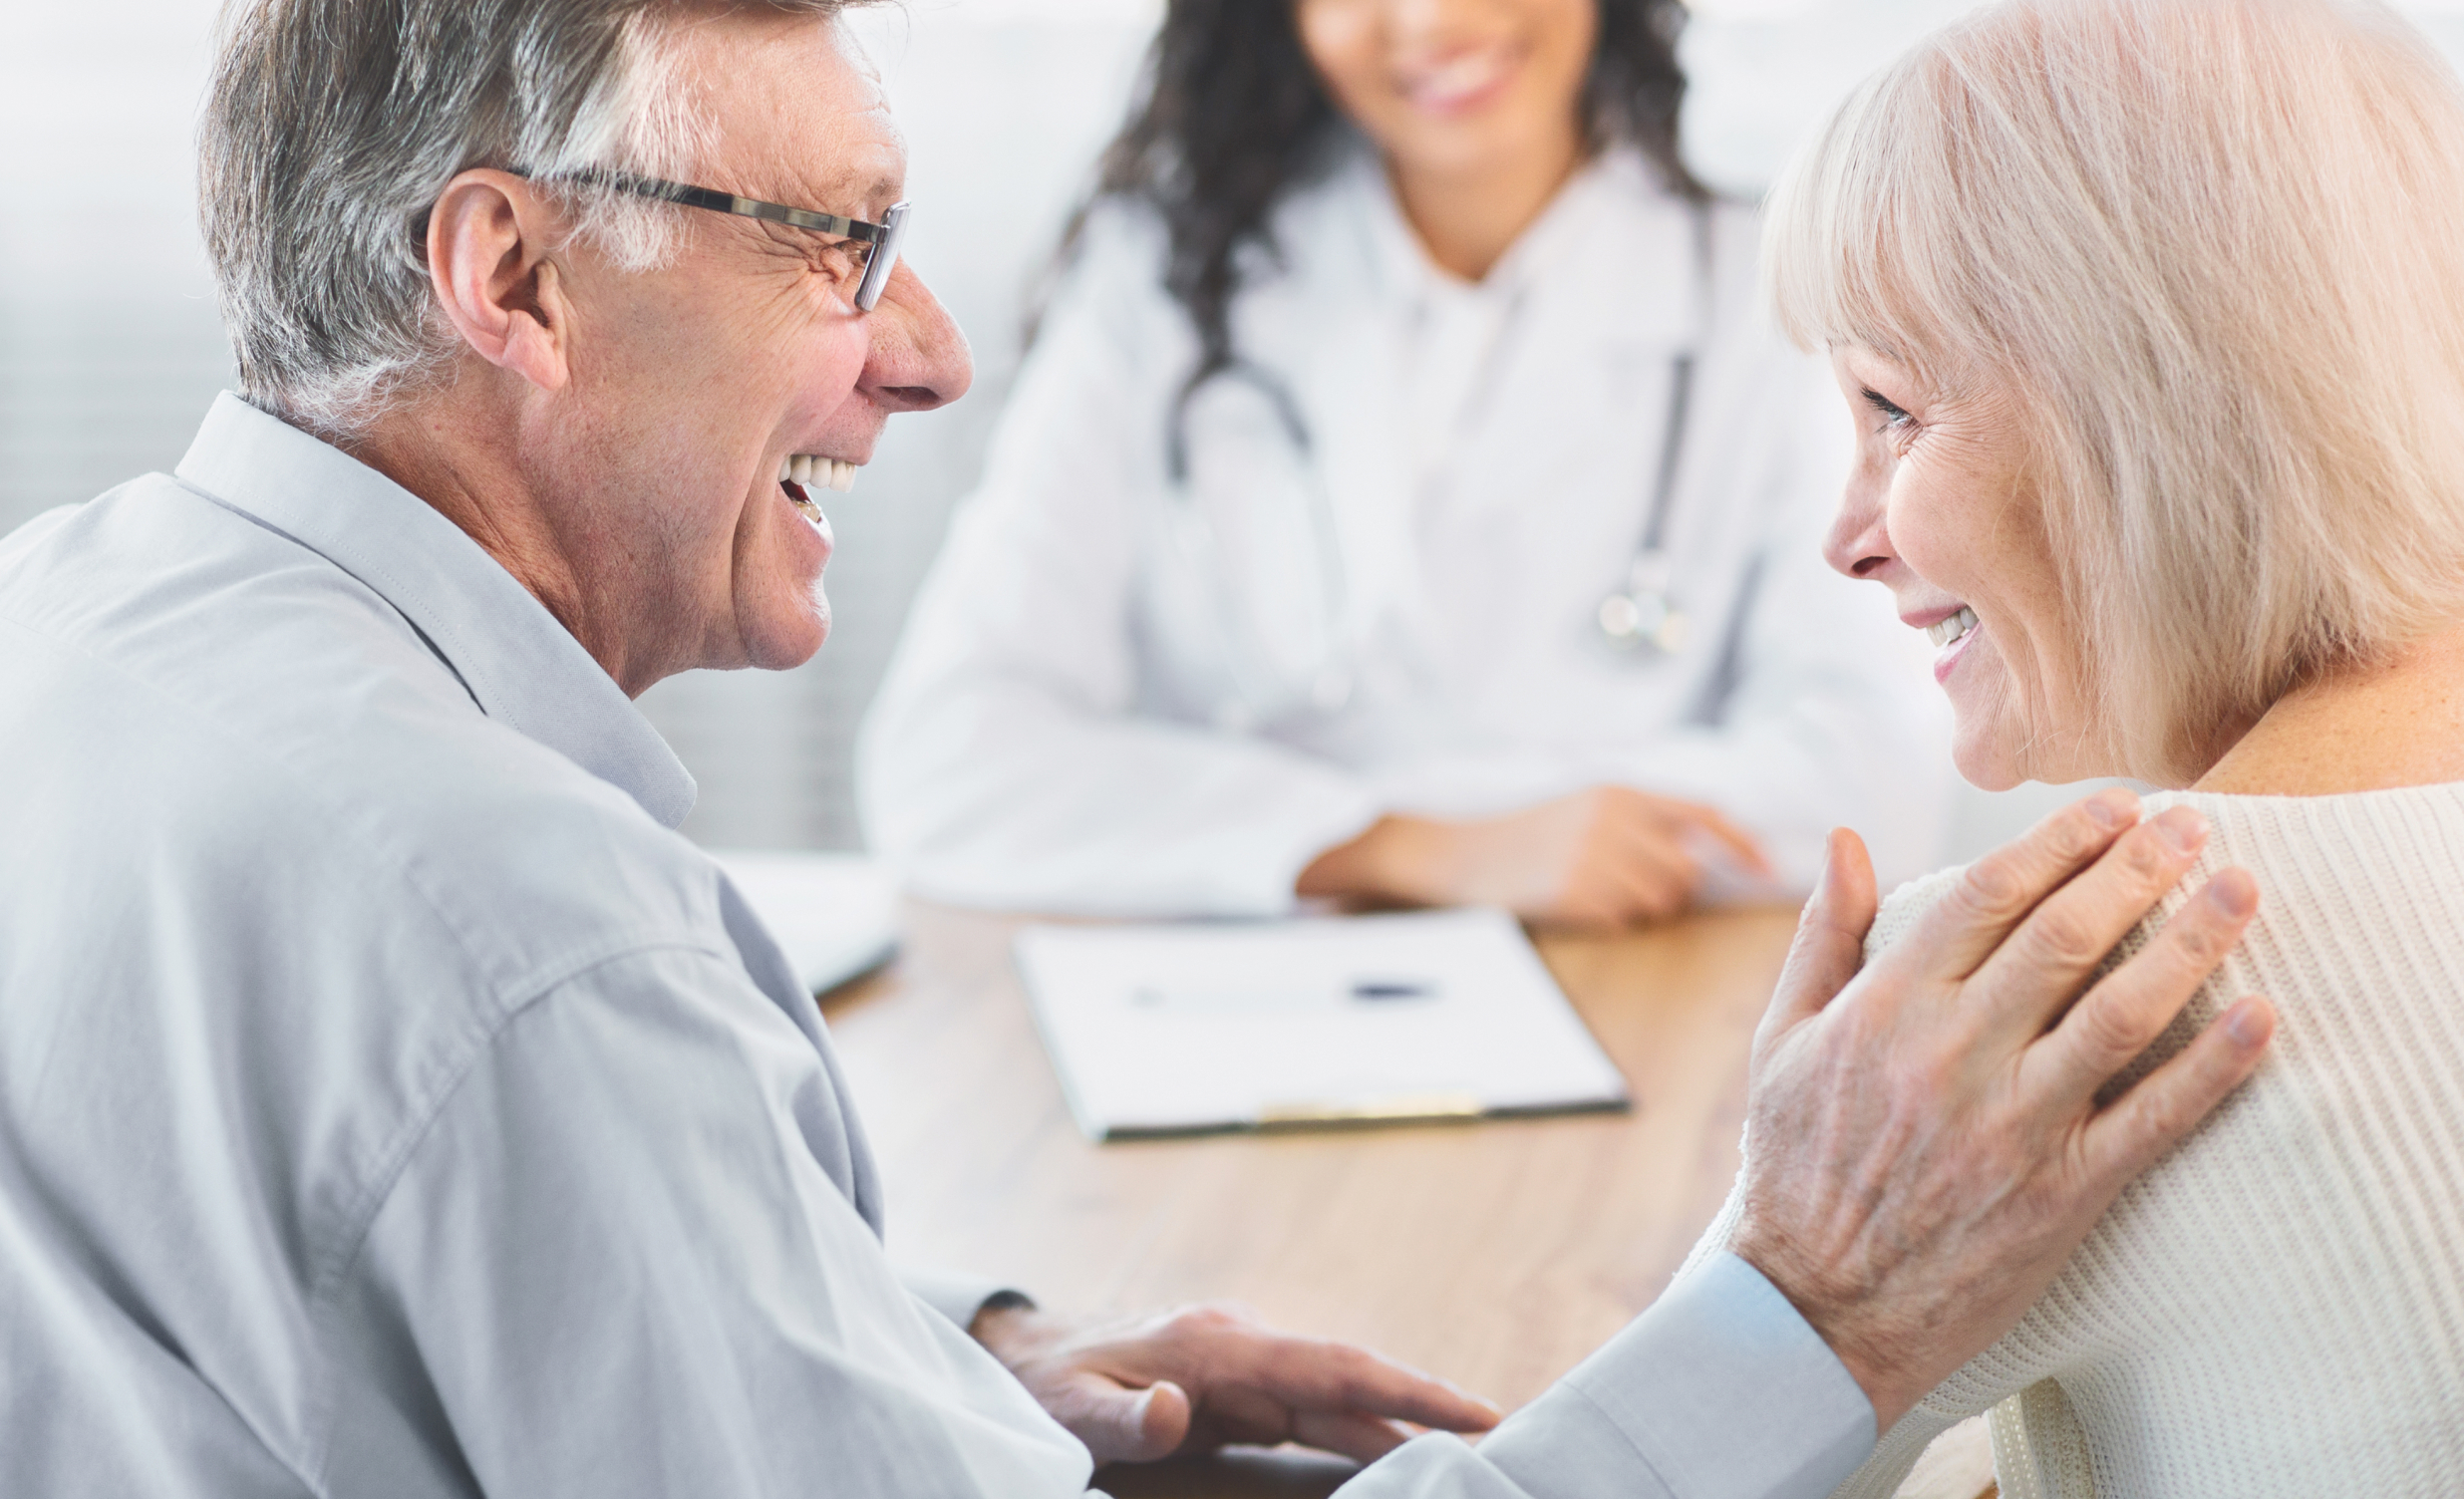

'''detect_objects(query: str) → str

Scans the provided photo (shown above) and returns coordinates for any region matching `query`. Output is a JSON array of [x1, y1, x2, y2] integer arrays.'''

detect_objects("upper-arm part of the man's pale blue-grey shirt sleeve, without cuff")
[[325, 949, 1089, 1499]]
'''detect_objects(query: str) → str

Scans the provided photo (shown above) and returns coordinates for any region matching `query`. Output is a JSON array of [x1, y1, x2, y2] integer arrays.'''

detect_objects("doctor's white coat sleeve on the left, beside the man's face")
[[857, 214, 1380, 915]]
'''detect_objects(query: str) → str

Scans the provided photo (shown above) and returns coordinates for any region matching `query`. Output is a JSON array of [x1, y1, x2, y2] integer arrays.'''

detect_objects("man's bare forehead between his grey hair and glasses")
[[678, 10, 907, 219]]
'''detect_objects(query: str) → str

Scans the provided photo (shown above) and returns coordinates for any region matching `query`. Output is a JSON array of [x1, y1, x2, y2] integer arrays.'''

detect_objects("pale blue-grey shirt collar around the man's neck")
[[177, 392, 695, 828]]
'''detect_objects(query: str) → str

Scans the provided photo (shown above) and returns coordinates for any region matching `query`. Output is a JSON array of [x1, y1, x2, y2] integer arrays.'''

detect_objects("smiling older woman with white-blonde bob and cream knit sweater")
[[1697, 0, 2464, 1499]]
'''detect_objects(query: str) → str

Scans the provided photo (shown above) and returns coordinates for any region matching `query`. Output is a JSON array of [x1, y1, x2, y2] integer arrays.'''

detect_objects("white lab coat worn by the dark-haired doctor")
[[857, 150, 1954, 915]]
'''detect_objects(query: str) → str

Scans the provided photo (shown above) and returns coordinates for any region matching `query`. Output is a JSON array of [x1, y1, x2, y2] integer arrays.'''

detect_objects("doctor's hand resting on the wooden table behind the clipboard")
[[1296, 786, 1771, 930]]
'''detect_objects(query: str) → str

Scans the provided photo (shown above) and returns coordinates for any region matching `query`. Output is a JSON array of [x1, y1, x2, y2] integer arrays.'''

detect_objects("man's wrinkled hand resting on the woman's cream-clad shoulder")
[[1734, 791, 2275, 1430]]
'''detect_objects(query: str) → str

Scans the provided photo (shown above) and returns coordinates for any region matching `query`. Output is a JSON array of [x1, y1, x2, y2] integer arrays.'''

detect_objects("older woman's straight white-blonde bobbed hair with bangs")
[[1766, 0, 2464, 784]]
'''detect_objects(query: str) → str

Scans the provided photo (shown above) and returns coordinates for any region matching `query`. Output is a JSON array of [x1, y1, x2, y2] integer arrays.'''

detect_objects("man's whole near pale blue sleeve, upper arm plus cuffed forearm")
[[323, 949, 1873, 1499]]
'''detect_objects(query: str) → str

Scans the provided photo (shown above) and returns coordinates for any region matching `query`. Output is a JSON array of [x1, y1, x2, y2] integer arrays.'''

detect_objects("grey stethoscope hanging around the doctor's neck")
[[1163, 202, 1712, 715]]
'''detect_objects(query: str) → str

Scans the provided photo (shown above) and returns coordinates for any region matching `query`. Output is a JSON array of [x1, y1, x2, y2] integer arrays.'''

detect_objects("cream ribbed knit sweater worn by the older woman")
[[1688, 784, 2464, 1499]]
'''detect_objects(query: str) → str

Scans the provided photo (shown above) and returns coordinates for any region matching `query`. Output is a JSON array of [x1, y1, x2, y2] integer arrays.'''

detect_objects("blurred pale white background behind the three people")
[[19, 0, 2464, 855]]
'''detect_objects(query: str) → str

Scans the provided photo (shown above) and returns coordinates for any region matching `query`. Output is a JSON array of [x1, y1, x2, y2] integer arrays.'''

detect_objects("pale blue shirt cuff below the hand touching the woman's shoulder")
[[1481, 1253, 1875, 1499]]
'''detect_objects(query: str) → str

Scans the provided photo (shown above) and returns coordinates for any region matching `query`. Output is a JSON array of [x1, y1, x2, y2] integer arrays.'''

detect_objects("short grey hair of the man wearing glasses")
[[197, 0, 845, 434]]
